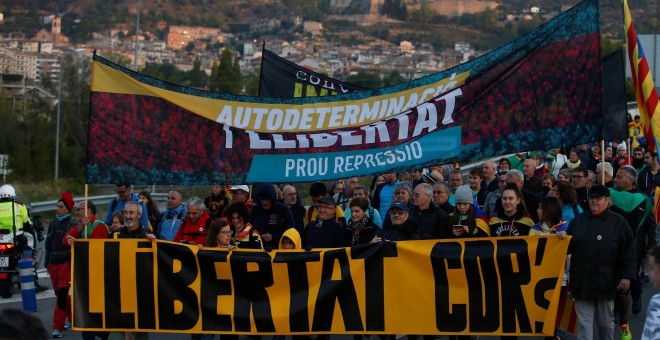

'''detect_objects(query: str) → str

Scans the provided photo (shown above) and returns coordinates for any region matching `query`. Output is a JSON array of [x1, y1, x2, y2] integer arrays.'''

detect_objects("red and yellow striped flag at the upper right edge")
[[623, 0, 660, 223]]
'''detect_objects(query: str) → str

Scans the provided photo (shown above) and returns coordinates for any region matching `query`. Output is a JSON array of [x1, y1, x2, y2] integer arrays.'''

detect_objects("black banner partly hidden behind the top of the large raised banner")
[[259, 48, 366, 98]]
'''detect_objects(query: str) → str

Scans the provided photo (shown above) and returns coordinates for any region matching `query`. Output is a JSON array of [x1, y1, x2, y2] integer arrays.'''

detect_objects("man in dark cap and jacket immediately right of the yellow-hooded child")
[[300, 196, 348, 249]]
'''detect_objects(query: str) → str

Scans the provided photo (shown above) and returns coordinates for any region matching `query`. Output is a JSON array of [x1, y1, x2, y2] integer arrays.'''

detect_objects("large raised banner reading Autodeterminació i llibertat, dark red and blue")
[[86, 0, 603, 185]]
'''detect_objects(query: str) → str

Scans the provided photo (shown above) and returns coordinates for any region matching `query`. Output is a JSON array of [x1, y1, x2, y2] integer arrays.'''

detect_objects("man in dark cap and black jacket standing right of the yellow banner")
[[558, 184, 636, 339]]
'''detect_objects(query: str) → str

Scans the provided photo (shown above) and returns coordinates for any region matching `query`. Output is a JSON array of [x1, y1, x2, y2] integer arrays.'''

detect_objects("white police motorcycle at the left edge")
[[0, 229, 34, 299]]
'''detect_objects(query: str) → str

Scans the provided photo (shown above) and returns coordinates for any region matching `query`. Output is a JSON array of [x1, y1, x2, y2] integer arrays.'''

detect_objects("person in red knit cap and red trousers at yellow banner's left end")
[[44, 191, 78, 338]]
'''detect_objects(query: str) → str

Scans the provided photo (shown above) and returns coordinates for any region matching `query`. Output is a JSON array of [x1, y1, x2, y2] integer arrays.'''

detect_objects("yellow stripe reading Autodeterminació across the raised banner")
[[91, 61, 470, 133]]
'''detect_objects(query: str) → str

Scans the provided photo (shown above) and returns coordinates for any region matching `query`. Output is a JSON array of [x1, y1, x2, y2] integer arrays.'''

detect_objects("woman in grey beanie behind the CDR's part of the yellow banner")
[[449, 185, 490, 237]]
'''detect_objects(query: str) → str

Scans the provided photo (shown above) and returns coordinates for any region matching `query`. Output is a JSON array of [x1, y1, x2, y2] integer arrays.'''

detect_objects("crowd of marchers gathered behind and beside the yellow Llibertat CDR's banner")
[[1, 137, 660, 339]]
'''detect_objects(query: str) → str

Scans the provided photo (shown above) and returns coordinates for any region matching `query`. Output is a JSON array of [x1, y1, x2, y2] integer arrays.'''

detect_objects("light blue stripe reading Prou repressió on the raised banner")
[[247, 126, 461, 182]]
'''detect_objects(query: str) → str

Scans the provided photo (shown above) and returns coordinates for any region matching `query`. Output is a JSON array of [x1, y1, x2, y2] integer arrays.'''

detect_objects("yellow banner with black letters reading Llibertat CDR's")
[[72, 235, 569, 335]]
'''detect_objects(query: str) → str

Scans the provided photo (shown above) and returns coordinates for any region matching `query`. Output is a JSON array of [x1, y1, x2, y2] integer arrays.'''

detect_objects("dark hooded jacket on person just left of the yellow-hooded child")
[[251, 184, 296, 247]]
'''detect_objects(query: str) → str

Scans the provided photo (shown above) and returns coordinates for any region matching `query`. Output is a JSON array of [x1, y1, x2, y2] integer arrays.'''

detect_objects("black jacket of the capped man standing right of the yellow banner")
[[567, 209, 637, 300]]
